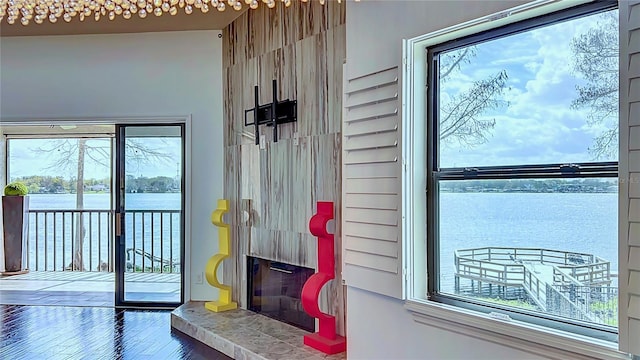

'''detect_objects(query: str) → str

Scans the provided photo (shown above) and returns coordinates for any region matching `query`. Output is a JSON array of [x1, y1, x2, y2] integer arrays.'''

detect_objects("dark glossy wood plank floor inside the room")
[[0, 305, 230, 360]]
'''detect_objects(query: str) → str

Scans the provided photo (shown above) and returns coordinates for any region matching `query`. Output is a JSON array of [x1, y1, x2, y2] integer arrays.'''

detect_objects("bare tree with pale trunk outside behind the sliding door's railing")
[[36, 138, 172, 271]]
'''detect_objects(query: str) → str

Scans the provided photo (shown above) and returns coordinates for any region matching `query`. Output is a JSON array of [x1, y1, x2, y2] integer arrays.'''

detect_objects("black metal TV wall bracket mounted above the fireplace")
[[244, 80, 298, 145]]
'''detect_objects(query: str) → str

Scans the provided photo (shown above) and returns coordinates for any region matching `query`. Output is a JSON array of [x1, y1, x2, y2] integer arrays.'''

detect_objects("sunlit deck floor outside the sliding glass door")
[[0, 271, 180, 307]]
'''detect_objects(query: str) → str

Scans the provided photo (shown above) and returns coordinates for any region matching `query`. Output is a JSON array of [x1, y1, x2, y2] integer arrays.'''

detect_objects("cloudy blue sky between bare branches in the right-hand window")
[[441, 8, 617, 167]]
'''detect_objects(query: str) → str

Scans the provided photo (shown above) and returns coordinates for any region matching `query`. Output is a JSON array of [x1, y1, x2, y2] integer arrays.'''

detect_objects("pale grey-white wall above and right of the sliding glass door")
[[0, 31, 223, 300]]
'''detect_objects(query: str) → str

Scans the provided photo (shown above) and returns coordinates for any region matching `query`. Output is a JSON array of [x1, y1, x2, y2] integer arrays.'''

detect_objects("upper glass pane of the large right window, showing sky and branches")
[[438, 10, 618, 168]]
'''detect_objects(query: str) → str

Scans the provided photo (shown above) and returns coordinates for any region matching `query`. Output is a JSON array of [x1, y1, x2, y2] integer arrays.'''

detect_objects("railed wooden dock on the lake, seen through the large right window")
[[454, 247, 618, 324]]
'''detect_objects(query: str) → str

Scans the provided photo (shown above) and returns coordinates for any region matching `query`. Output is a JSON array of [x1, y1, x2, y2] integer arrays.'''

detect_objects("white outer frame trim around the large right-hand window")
[[402, 1, 628, 358]]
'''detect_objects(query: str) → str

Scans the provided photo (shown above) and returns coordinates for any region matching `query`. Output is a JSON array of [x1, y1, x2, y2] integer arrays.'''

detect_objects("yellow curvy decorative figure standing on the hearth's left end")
[[204, 199, 238, 312]]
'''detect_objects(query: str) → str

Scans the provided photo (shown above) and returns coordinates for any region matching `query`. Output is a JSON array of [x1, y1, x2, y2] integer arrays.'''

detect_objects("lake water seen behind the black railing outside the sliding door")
[[29, 193, 180, 271]]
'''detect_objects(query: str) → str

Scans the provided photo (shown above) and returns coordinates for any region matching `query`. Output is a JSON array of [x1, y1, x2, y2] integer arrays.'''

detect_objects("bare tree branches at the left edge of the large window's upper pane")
[[439, 46, 508, 147]]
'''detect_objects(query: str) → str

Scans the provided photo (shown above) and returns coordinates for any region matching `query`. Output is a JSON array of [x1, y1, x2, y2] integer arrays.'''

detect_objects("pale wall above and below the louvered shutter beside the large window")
[[347, 0, 584, 360]]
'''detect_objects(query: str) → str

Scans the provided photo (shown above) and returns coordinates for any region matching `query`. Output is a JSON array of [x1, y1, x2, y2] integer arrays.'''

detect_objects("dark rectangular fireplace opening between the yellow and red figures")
[[247, 256, 315, 332]]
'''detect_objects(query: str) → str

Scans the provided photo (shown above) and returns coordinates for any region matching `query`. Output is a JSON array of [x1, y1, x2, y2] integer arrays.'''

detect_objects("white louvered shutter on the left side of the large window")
[[342, 67, 404, 299]]
